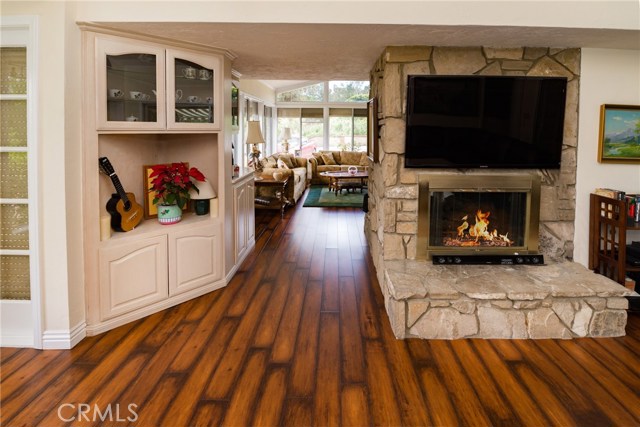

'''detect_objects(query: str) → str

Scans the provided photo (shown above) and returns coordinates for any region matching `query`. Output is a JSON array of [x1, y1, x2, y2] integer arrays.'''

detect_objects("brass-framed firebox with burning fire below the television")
[[416, 174, 540, 259]]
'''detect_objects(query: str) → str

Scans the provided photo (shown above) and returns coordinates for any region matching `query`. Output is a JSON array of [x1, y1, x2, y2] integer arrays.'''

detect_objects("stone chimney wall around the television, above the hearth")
[[365, 46, 580, 274]]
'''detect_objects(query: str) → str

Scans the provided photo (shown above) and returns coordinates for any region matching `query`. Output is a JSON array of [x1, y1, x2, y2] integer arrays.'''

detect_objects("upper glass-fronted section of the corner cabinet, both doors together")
[[95, 36, 223, 130]]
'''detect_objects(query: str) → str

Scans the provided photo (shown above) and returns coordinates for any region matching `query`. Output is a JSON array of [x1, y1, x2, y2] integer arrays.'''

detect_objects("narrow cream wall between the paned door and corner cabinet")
[[2, 2, 79, 345]]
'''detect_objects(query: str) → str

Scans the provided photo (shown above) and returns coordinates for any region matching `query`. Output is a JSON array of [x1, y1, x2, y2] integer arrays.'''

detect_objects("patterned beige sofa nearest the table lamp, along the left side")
[[256, 153, 308, 204]]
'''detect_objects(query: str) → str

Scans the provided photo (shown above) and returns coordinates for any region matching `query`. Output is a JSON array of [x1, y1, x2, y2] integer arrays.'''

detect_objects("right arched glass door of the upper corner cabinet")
[[167, 50, 222, 129]]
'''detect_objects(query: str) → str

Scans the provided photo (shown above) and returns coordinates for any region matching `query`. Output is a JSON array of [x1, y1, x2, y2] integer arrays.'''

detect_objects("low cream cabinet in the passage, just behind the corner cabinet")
[[233, 174, 256, 263]]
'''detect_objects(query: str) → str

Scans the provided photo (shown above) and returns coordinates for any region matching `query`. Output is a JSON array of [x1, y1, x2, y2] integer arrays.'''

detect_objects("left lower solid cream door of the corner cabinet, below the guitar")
[[99, 236, 168, 320]]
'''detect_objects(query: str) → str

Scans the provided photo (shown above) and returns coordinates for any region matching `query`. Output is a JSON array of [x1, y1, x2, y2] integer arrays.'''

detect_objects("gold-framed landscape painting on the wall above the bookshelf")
[[598, 104, 640, 163]]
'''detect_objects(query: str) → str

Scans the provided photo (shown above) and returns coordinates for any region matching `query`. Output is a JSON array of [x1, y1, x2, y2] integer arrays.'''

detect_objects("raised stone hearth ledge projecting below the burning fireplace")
[[381, 261, 631, 339]]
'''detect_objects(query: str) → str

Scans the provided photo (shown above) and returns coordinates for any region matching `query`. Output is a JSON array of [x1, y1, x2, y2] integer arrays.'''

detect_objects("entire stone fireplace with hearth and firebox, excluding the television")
[[365, 46, 630, 339]]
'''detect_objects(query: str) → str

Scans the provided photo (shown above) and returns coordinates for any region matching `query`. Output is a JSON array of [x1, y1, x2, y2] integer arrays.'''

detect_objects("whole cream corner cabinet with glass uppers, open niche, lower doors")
[[80, 23, 235, 335]]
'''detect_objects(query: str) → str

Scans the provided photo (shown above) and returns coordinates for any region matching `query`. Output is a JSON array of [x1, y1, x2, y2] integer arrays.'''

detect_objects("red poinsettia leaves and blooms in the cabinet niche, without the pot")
[[149, 162, 204, 209]]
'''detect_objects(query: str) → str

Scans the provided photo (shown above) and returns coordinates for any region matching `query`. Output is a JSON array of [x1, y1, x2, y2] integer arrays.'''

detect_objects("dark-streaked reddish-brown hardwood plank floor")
[[0, 203, 640, 427]]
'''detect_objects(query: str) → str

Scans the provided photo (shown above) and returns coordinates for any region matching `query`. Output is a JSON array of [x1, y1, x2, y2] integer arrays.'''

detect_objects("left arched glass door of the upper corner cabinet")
[[97, 40, 166, 129]]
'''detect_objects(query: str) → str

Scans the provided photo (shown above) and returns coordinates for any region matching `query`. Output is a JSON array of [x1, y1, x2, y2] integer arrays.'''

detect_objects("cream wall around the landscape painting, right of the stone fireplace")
[[574, 49, 640, 266]]
